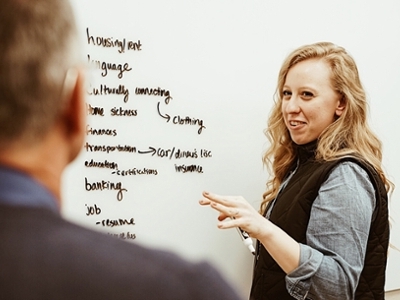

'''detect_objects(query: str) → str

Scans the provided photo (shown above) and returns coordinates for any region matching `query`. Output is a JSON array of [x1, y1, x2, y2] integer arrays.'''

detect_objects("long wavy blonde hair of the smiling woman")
[[260, 42, 392, 213]]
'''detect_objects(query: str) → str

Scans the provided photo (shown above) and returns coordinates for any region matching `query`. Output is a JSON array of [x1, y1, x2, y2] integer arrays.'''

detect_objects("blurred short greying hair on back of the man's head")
[[0, 0, 80, 150]]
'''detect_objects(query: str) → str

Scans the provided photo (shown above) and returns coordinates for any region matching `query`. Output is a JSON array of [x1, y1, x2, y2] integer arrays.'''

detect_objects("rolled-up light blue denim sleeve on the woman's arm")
[[286, 162, 376, 300]]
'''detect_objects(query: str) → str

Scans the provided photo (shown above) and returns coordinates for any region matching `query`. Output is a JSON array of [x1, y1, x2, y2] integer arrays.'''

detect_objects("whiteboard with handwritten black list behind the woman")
[[63, 0, 400, 295]]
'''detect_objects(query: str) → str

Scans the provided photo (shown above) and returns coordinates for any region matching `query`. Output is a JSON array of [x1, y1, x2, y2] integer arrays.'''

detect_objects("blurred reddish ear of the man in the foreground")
[[62, 68, 86, 161]]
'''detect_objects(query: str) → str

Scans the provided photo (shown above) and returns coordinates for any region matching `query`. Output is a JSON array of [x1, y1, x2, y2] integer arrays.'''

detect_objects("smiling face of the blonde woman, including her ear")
[[282, 59, 344, 145]]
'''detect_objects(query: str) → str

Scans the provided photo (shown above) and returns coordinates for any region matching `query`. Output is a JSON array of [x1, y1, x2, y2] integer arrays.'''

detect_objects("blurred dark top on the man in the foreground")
[[0, 168, 239, 300]]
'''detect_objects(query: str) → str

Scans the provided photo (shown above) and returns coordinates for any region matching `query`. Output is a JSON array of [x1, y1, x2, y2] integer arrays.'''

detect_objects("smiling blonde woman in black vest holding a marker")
[[200, 43, 391, 300]]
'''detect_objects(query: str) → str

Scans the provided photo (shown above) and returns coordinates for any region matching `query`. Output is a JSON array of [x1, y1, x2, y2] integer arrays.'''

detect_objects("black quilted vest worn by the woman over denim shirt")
[[250, 146, 389, 300]]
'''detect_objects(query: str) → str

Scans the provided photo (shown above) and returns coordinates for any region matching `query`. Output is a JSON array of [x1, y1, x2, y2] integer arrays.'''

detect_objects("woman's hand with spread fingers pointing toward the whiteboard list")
[[199, 192, 270, 238]]
